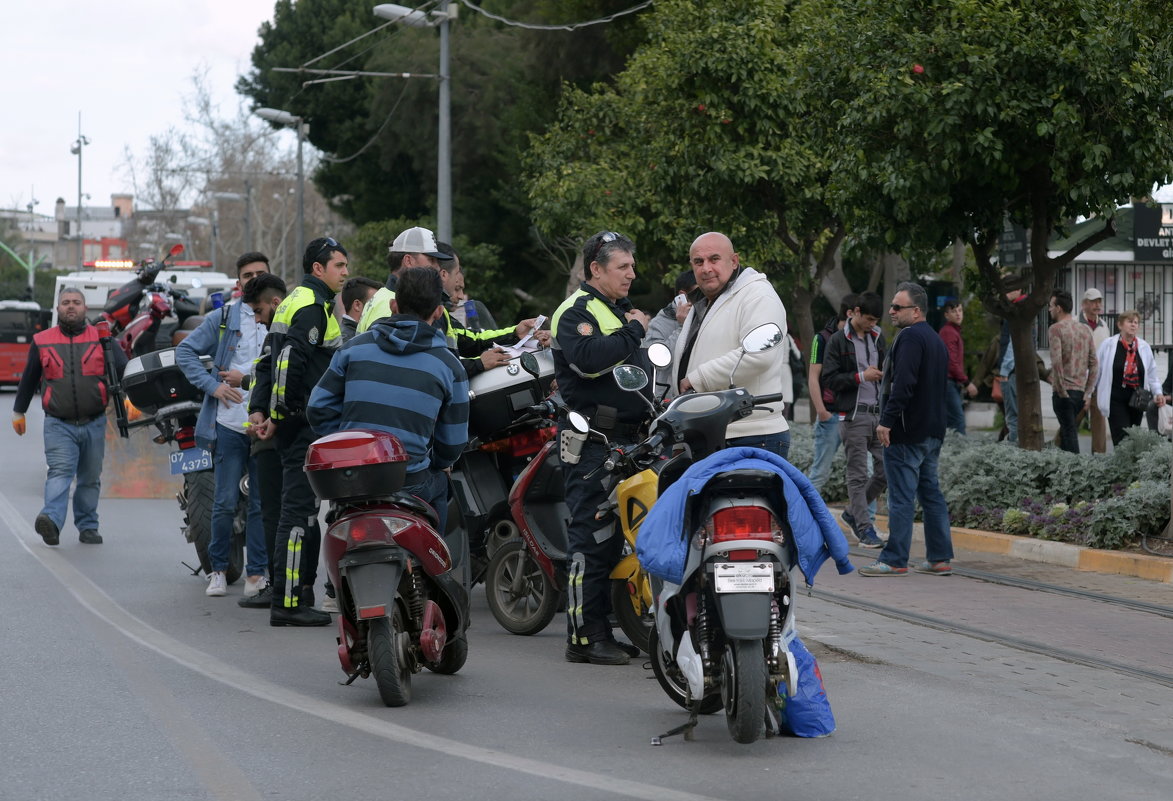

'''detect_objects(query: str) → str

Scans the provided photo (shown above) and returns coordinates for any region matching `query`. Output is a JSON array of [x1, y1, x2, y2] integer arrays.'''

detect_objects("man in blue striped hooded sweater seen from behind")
[[306, 267, 468, 539]]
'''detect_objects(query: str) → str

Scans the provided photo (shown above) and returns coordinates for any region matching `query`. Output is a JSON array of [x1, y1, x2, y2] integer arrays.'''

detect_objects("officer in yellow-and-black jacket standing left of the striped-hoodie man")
[[249, 237, 347, 626]]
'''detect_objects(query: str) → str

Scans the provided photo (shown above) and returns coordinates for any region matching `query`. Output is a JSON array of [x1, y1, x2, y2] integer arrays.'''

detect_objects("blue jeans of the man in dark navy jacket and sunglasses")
[[879, 437, 952, 568]]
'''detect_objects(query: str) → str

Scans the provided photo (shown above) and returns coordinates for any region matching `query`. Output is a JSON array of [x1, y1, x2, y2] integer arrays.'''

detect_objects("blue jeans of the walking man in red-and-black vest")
[[41, 414, 106, 531]]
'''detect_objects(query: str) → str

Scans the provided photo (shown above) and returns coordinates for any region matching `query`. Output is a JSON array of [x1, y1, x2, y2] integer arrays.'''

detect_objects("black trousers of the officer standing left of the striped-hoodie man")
[[272, 420, 321, 607]]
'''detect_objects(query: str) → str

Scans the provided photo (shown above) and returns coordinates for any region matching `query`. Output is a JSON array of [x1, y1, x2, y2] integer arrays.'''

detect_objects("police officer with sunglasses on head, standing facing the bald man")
[[550, 231, 652, 665]]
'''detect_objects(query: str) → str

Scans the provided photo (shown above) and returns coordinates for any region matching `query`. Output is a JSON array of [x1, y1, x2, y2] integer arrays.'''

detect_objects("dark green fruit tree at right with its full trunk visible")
[[791, 0, 1173, 449]]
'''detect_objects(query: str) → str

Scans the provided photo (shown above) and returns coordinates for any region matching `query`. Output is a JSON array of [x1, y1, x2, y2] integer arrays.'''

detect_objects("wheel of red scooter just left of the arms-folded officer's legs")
[[484, 539, 565, 636]]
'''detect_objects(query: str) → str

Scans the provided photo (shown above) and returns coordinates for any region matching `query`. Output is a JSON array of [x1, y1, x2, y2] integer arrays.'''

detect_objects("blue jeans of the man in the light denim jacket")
[[208, 423, 269, 576]]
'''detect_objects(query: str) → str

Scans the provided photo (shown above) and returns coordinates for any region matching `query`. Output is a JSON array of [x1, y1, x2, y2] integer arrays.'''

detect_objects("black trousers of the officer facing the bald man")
[[562, 442, 623, 645]]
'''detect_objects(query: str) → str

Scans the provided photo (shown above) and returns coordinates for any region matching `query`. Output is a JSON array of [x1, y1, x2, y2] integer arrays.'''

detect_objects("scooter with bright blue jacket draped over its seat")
[[614, 324, 852, 745]]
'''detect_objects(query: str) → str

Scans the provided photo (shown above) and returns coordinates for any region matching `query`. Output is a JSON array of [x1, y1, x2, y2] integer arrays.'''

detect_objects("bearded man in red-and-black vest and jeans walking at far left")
[[12, 286, 127, 545]]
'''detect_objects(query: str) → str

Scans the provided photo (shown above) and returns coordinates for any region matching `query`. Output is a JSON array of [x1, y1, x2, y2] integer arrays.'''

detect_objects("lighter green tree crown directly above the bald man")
[[527, 0, 846, 351]]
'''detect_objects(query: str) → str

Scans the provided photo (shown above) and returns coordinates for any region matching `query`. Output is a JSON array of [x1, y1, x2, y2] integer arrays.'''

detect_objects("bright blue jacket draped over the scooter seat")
[[636, 448, 854, 586]]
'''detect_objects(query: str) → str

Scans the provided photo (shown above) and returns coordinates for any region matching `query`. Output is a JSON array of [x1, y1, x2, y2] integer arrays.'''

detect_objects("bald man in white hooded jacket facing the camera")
[[673, 232, 791, 459]]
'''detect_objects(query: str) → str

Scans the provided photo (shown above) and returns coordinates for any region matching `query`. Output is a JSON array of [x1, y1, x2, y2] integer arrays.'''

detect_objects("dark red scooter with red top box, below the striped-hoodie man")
[[305, 428, 468, 706]]
